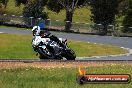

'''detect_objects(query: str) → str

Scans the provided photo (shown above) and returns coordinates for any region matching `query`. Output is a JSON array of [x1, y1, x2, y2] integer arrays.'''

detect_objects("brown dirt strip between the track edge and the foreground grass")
[[0, 61, 132, 69]]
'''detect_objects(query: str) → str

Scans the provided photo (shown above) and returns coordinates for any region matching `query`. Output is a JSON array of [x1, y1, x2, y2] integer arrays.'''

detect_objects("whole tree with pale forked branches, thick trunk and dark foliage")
[[48, 0, 89, 31]]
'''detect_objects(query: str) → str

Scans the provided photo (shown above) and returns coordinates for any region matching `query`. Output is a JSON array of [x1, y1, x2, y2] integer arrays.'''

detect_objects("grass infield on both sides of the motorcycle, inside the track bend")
[[0, 34, 127, 59]]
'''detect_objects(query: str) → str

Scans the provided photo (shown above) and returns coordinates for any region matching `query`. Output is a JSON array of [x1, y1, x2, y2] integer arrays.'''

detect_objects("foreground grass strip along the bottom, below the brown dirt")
[[0, 65, 132, 88]]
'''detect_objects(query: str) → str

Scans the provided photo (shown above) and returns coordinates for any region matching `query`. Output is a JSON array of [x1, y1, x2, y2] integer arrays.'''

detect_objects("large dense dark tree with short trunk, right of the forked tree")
[[90, 0, 119, 35]]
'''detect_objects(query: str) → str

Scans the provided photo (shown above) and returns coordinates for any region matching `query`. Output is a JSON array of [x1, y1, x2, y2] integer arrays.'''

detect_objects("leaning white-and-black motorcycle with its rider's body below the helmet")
[[32, 35, 76, 60]]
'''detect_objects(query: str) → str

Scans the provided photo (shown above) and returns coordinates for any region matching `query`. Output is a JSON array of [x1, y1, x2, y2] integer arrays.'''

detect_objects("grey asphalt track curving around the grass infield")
[[0, 28, 132, 62]]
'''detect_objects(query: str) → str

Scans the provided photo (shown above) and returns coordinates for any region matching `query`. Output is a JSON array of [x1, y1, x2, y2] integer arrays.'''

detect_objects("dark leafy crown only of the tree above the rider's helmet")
[[23, 0, 48, 19]]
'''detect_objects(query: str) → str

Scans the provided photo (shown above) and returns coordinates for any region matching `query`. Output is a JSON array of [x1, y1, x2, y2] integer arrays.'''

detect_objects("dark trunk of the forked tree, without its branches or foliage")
[[65, 10, 73, 32]]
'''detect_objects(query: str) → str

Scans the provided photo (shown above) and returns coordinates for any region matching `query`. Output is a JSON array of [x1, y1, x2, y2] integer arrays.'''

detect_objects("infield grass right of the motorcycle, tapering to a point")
[[69, 42, 127, 57]]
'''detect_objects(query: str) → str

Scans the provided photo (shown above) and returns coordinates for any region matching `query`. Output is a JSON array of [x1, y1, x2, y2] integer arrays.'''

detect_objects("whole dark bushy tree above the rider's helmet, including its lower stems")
[[15, 0, 48, 26]]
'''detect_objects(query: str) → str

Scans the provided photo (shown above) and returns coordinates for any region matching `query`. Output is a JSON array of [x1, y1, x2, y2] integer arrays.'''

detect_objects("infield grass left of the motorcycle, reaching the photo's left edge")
[[0, 34, 35, 59]]
